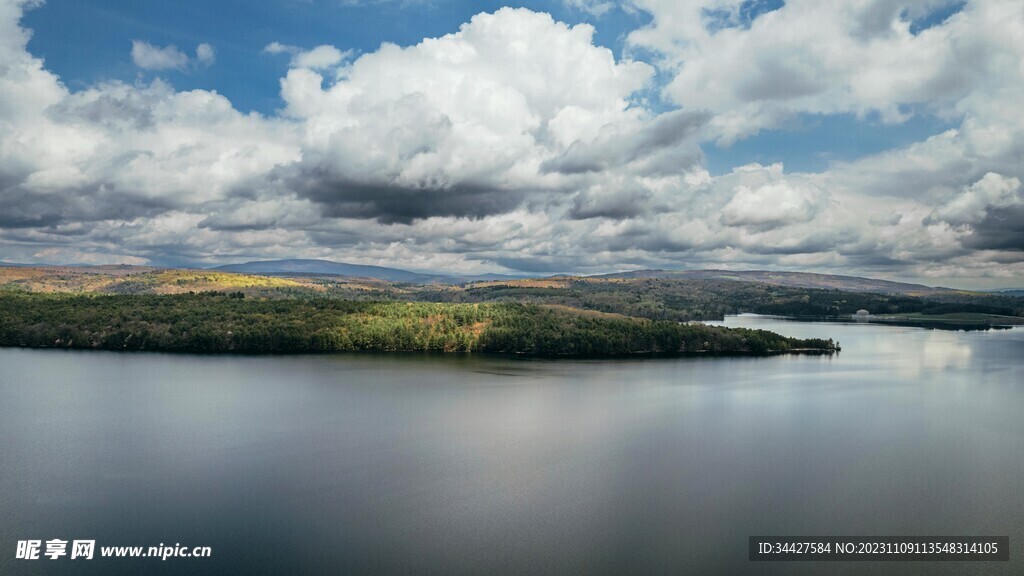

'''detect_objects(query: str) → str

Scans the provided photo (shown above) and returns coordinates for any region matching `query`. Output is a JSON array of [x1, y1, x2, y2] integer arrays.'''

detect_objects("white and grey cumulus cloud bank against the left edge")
[[0, 2, 298, 233]]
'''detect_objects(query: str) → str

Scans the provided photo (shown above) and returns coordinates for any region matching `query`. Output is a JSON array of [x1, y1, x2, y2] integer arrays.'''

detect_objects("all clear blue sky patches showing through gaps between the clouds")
[[25, 0, 963, 175]]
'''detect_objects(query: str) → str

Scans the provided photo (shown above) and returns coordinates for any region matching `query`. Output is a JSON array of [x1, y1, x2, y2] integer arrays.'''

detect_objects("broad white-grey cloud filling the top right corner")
[[629, 0, 1021, 143]]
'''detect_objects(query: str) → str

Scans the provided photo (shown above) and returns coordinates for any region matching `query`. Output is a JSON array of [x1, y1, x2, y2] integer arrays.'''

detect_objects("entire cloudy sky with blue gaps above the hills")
[[0, 0, 1024, 289]]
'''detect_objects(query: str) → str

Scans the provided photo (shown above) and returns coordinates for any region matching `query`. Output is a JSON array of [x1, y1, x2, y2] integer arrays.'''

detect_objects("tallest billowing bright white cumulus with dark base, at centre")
[[272, 8, 655, 221]]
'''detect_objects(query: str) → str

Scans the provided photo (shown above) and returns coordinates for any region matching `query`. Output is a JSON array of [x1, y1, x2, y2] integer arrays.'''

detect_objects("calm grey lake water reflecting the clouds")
[[0, 317, 1024, 575]]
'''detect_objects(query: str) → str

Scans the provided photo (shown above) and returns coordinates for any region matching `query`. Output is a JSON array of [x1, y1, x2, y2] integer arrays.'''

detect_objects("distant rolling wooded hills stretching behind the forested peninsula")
[[6, 262, 1024, 322]]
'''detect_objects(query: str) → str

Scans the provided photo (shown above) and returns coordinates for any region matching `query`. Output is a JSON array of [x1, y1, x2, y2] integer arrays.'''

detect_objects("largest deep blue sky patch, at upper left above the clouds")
[[25, 0, 650, 114]]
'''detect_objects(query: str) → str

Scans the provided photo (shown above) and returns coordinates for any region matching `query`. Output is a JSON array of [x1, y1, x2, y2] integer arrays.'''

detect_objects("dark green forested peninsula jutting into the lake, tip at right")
[[0, 291, 839, 357]]
